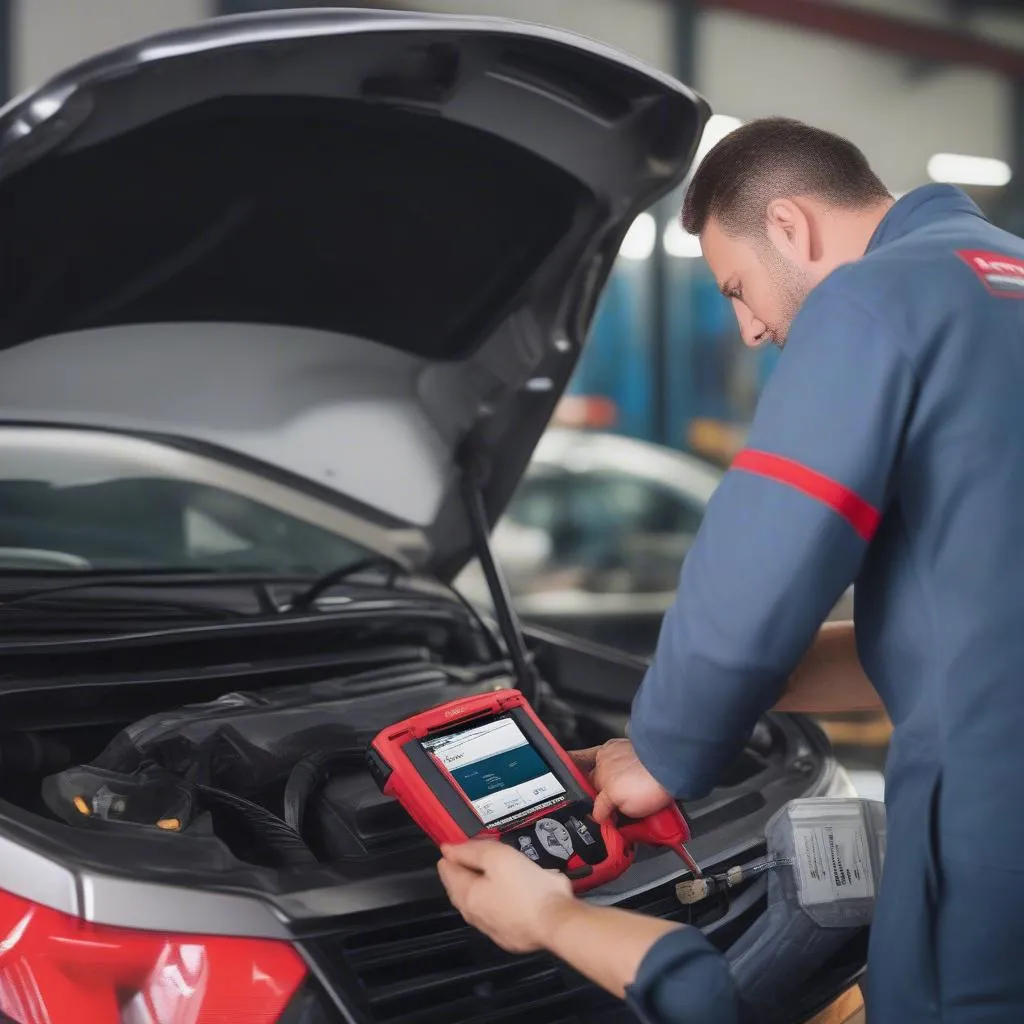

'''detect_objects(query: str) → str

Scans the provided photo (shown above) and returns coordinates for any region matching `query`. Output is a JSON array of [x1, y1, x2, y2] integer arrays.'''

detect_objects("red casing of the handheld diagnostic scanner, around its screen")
[[367, 690, 699, 893]]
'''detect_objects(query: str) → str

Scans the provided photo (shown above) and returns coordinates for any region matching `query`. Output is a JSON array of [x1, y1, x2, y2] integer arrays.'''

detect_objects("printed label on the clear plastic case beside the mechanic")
[[793, 808, 874, 906]]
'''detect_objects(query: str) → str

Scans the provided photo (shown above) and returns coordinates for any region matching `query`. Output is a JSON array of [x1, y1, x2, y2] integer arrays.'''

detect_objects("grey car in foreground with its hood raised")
[[0, 9, 866, 1024]]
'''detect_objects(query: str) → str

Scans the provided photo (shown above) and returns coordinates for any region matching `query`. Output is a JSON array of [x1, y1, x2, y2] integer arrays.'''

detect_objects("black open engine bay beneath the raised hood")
[[0, 586, 829, 913]]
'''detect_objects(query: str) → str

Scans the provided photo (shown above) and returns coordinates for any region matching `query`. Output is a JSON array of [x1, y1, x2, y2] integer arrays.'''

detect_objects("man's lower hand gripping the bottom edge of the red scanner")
[[437, 840, 573, 953]]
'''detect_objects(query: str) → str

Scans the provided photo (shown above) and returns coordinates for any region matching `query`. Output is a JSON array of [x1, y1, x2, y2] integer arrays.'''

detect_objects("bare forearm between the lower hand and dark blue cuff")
[[546, 899, 682, 998]]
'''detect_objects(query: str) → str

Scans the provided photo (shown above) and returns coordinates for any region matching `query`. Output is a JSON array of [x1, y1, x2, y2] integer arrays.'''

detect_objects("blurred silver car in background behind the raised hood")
[[458, 427, 853, 656]]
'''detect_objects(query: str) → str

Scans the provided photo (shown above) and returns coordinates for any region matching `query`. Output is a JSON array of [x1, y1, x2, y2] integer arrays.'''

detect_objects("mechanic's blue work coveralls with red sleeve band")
[[630, 185, 1024, 1024]]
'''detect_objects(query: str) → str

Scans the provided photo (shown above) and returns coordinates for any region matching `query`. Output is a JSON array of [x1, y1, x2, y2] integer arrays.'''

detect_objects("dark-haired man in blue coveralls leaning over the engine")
[[443, 119, 1024, 1024]]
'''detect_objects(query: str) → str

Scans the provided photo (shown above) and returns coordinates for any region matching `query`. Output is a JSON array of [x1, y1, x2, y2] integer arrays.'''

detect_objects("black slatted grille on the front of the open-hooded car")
[[305, 865, 764, 1024]]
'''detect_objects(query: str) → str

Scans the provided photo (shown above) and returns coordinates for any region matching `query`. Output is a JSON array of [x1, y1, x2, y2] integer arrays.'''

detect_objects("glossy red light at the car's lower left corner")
[[0, 892, 306, 1024]]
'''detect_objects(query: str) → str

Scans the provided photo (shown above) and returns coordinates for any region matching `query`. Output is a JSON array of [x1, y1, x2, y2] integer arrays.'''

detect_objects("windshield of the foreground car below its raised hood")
[[0, 431, 374, 575]]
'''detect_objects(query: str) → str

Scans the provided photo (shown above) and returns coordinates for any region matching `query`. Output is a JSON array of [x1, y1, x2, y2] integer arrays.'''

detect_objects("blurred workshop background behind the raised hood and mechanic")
[[9, 0, 1024, 793]]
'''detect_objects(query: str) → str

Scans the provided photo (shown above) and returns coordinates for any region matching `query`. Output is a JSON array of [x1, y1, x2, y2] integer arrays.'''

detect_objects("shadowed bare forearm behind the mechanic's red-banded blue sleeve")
[[775, 623, 884, 715]]
